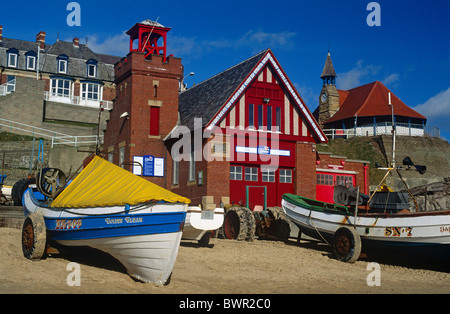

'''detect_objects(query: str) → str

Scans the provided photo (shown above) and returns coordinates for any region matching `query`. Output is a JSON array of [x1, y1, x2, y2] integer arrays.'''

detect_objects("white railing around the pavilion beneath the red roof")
[[323, 122, 440, 139]]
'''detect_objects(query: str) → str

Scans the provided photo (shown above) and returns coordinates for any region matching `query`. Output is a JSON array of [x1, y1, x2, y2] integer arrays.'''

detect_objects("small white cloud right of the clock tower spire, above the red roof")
[[336, 60, 381, 90]]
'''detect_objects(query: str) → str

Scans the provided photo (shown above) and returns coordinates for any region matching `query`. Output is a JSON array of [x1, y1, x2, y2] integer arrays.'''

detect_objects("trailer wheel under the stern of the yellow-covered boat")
[[22, 213, 47, 260]]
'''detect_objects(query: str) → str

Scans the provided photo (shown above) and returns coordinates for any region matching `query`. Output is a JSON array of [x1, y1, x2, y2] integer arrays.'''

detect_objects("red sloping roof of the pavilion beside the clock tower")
[[325, 81, 426, 124]]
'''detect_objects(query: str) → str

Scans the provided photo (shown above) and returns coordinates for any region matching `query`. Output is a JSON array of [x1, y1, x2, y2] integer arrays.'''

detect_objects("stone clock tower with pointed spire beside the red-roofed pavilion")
[[318, 51, 339, 128]]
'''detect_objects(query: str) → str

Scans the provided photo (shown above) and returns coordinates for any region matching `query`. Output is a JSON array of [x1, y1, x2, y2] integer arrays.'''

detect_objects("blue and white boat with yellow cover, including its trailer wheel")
[[22, 157, 190, 285]]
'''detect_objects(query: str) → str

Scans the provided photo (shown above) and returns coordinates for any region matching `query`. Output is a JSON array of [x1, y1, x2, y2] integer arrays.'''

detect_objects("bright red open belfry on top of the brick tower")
[[127, 20, 170, 62]]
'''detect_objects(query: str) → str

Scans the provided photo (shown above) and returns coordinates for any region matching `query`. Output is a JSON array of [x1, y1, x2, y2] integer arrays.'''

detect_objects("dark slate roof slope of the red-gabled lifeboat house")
[[178, 49, 268, 130]]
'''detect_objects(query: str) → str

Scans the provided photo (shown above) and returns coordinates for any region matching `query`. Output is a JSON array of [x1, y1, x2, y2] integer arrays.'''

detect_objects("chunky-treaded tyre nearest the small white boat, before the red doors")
[[223, 206, 255, 241]]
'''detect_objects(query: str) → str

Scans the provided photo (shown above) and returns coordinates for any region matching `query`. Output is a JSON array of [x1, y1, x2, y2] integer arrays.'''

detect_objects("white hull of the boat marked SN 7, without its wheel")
[[282, 194, 450, 253]]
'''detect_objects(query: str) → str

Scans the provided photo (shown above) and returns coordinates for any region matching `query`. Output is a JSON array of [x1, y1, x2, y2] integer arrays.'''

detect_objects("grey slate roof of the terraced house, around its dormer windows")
[[0, 37, 120, 82]]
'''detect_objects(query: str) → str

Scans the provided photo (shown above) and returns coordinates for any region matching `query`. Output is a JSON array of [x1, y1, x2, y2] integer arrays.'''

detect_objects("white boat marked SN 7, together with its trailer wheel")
[[282, 194, 450, 262]]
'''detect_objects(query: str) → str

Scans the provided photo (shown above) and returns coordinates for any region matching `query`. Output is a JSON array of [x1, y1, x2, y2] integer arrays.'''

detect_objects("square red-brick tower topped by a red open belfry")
[[104, 20, 183, 187]]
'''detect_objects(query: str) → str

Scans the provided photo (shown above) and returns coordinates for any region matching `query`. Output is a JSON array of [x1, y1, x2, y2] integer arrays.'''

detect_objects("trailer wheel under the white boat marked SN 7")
[[331, 227, 361, 263]]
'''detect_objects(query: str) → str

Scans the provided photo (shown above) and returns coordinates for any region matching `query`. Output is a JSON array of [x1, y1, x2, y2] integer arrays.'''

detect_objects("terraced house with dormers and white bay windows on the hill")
[[0, 26, 119, 142]]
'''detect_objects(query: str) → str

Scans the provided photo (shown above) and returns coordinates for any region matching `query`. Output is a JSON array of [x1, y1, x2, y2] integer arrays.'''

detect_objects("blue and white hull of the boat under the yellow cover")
[[23, 189, 187, 285]]
